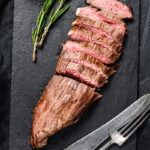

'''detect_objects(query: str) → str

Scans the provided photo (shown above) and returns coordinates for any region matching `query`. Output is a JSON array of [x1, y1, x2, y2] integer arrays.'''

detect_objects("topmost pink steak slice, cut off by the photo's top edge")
[[86, 0, 133, 19]]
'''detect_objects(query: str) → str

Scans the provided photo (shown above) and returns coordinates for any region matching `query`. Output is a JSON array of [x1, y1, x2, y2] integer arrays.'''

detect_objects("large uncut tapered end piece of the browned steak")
[[30, 75, 101, 148]]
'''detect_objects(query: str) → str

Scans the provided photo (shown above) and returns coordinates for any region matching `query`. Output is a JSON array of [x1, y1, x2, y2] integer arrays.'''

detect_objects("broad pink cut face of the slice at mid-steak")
[[63, 41, 118, 64]]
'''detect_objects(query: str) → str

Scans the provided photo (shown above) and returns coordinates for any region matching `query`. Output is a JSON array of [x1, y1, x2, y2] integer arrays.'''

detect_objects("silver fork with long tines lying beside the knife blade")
[[99, 105, 150, 150]]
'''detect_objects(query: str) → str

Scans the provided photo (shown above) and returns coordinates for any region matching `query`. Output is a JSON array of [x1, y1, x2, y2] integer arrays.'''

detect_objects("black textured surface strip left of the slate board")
[[0, 0, 13, 150]]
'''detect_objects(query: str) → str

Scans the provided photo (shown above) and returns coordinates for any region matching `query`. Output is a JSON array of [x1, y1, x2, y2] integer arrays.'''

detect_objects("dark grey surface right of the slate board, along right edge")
[[137, 4, 150, 150]]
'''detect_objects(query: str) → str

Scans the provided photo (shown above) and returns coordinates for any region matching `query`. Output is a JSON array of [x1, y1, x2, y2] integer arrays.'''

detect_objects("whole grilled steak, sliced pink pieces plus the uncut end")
[[30, 0, 133, 148]]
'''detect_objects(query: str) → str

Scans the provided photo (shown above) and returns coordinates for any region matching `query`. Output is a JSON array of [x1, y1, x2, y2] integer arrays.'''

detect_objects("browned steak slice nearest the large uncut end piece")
[[56, 58, 108, 88]]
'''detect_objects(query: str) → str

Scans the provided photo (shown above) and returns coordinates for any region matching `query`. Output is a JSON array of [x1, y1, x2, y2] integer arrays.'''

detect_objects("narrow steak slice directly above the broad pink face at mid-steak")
[[68, 26, 122, 54]]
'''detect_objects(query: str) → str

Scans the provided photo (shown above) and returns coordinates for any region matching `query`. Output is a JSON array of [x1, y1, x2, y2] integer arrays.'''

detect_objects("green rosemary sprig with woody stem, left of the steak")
[[32, 0, 70, 61]]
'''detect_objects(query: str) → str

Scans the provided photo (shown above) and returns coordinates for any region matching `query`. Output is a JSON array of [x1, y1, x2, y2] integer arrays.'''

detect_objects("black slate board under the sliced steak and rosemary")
[[9, 0, 139, 150]]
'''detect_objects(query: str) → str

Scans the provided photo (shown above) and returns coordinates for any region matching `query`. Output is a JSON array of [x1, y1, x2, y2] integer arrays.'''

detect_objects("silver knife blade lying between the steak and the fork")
[[64, 94, 150, 150]]
